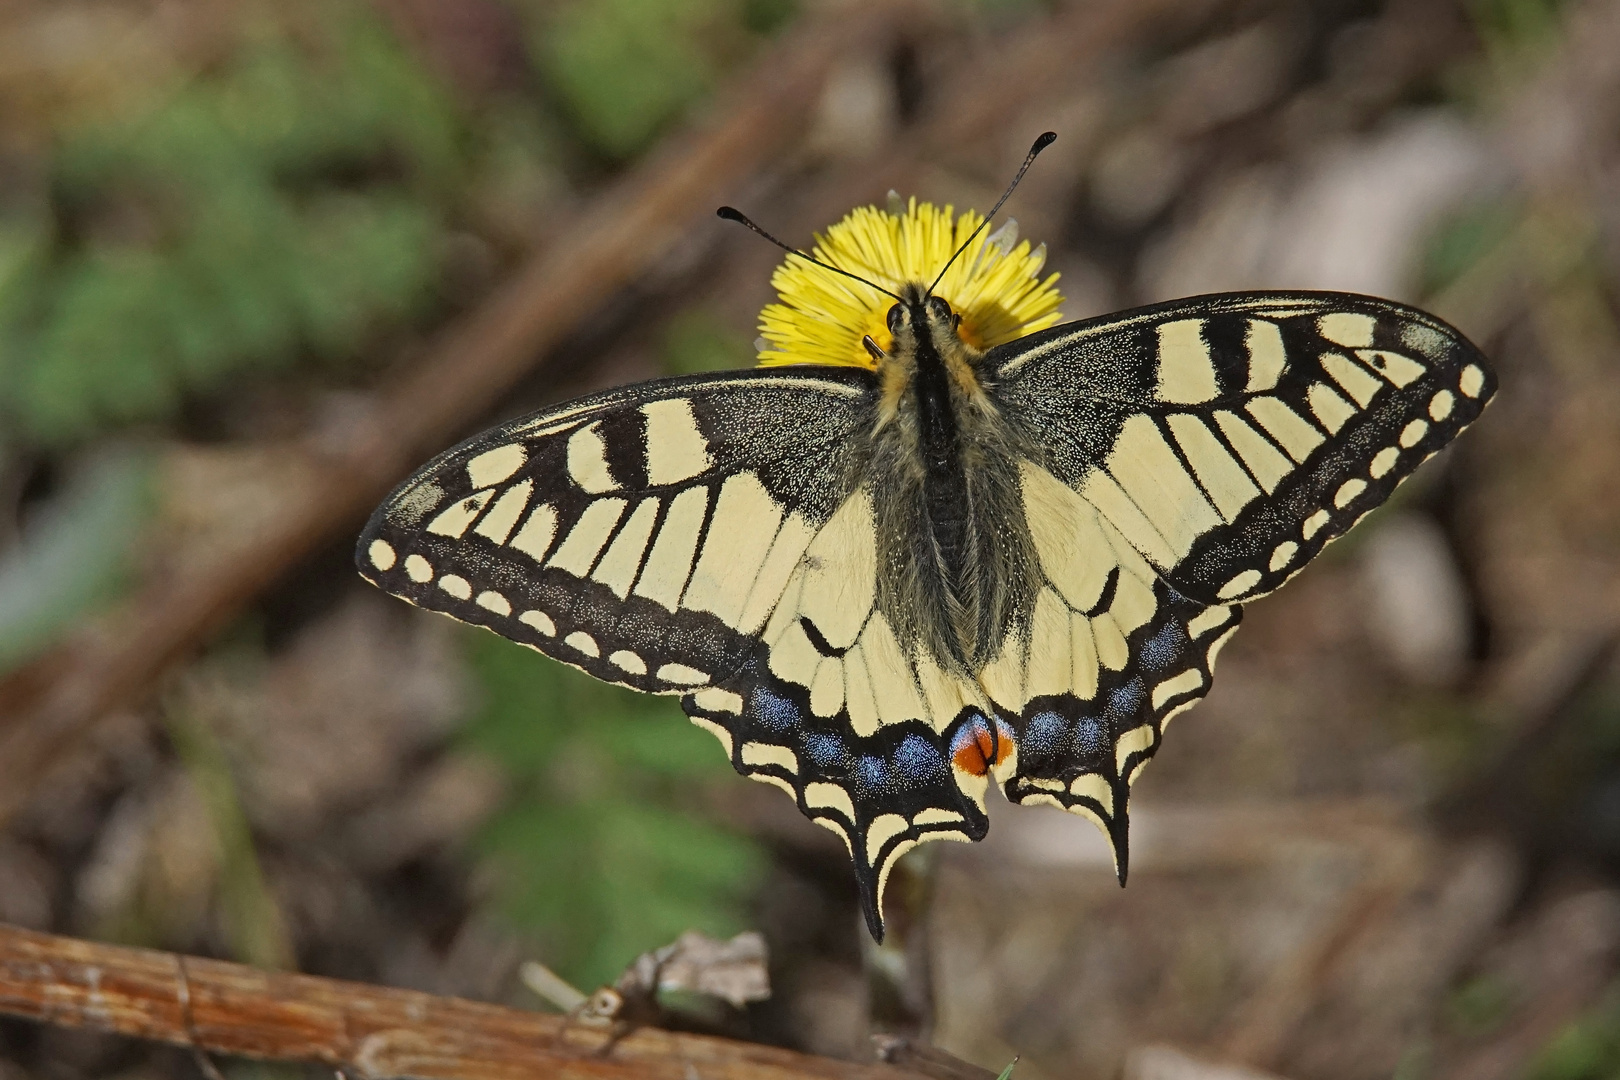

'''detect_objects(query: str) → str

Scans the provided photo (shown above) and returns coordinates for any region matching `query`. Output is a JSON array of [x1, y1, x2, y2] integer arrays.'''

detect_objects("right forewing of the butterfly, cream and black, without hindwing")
[[987, 293, 1495, 604]]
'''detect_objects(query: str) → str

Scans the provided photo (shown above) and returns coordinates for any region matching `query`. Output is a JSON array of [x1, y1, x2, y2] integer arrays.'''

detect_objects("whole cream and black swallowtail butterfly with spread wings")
[[356, 136, 1495, 941]]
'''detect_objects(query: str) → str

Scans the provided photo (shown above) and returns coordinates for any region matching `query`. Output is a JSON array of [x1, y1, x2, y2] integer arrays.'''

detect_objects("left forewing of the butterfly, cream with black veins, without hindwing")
[[356, 368, 872, 696]]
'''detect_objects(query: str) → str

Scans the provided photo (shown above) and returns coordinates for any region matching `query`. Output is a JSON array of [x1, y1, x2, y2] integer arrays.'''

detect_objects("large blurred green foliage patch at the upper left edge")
[[0, 3, 468, 444]]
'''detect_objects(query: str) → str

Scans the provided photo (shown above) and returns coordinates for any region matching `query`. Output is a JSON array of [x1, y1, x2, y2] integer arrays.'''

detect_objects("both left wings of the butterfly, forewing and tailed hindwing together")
[[356, 368, 991, 938]]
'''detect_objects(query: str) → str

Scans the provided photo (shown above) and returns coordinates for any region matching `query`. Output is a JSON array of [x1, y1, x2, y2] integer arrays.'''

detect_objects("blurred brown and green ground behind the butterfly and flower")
[[0, 0, 1620, 1080]]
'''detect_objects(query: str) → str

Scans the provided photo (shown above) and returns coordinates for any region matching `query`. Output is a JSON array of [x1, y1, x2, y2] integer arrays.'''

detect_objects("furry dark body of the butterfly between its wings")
[[862, 285, 1034, 674]]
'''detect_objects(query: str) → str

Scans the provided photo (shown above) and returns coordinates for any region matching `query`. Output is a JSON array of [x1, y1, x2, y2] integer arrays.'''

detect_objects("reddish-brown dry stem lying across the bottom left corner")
[[0, 925, 925, 1080]]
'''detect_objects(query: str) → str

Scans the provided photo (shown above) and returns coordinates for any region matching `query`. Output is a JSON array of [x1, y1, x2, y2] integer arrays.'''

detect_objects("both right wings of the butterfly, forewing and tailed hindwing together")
[[985, 293, 1495, 878]]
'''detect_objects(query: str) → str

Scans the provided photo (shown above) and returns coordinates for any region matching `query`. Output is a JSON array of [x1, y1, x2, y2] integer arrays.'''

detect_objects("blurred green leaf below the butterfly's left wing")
[[462, 631, 765, 989]]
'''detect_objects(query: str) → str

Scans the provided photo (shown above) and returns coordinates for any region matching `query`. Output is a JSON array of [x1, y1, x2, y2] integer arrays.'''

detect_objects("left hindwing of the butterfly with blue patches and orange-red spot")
[[682, 487, 1013, 938]]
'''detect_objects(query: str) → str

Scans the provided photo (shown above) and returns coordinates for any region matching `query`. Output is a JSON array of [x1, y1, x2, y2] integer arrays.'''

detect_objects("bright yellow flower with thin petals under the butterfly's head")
[[760, 199, 1063, 368]]
